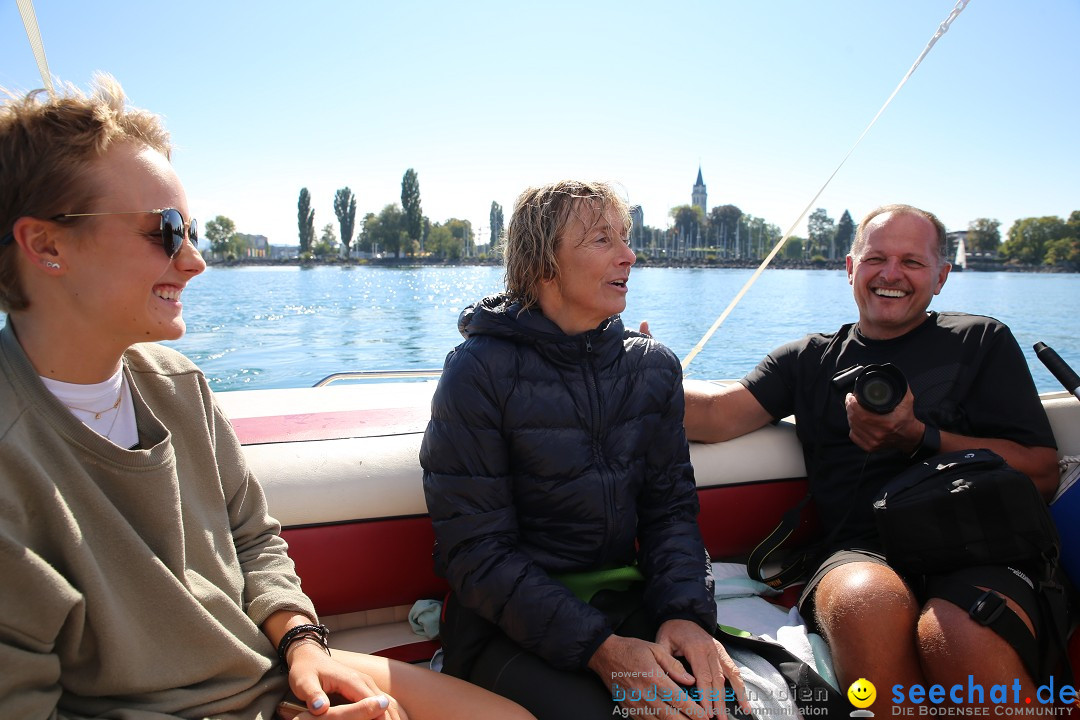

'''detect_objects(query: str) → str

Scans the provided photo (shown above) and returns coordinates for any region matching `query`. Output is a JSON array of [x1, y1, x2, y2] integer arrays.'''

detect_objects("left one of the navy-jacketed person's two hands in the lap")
[[589, 628, 705, 718]]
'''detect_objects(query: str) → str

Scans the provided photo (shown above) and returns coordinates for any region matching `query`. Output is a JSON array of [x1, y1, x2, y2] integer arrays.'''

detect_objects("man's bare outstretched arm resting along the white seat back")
[[683, 380, 772, 443]]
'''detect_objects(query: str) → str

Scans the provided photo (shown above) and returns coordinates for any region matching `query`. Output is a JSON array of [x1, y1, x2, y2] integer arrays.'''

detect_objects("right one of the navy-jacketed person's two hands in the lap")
[[657, 620, 751, 718]]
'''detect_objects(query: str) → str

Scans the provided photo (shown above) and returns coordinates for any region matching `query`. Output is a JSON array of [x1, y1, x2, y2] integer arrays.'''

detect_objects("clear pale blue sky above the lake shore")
[[0, 0, 1080, 244]]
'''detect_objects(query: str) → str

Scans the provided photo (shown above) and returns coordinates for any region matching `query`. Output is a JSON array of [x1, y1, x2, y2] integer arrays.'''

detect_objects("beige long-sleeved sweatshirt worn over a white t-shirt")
[[0, 321, 315, 720]]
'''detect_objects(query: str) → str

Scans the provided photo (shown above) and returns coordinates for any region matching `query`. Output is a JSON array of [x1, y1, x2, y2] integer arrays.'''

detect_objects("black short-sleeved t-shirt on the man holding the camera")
[[741, 313, 1056, 541]]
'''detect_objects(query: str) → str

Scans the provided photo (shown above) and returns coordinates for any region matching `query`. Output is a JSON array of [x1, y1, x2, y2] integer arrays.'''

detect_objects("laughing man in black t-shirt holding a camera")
[[686, 205, 1057, 708]]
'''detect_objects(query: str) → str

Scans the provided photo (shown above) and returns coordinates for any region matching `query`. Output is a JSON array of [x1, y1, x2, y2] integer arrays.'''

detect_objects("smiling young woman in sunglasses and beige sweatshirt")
[[0, 78, 527, 720]]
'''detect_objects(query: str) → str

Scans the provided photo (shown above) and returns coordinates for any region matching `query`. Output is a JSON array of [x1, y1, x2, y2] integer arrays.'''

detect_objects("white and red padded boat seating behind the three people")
[[218, 382, 1080, 661]]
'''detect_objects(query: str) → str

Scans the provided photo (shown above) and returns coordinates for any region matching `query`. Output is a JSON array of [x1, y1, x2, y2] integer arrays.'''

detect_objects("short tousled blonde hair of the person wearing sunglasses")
[[0, 73, 172, 312]]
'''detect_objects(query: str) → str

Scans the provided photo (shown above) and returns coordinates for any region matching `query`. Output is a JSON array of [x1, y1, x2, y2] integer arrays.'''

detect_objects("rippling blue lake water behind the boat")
[[156, 267, 1080, 391]]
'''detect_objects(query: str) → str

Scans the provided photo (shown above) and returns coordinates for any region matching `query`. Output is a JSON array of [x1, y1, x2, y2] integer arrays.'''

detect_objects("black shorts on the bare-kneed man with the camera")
[[798, 543, 1055, 679]]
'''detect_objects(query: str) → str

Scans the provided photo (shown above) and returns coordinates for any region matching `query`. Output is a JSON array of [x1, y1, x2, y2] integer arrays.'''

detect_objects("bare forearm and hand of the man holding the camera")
[[842, 390, 1058, 501]]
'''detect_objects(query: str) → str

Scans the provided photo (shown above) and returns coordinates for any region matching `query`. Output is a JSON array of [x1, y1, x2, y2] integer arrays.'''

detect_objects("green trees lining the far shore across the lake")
[[204, 168, 1080, 272]]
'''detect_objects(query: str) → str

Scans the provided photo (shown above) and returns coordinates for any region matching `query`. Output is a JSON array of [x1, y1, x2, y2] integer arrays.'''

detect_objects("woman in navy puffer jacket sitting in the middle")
[[420, 181, 742, 720]]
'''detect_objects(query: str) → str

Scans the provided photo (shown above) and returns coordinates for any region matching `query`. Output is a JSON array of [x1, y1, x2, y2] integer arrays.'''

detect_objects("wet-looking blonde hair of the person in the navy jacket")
[[503, 180, 630, 309]]
